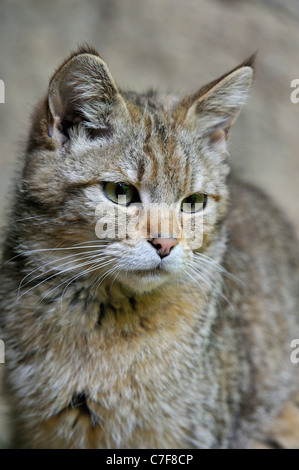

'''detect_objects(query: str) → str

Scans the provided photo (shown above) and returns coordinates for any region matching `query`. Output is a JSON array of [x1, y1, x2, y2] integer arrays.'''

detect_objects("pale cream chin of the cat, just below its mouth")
[[118, 269, 173, 294]]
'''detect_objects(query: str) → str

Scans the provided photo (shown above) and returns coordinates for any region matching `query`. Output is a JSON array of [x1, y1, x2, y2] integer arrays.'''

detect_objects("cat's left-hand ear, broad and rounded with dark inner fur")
[[48, 44, 127, 145]]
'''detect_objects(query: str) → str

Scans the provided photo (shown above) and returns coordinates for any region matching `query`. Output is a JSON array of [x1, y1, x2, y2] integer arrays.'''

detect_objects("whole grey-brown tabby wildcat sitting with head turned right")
[[0, 47, 299, 449]]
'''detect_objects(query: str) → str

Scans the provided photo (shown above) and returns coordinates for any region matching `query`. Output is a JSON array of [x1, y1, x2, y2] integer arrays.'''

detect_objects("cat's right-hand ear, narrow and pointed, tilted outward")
[[183, 55, 255, 152]]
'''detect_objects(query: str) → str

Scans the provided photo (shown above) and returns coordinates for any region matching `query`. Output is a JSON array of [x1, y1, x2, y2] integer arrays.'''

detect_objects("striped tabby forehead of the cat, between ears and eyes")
[[70, 96, 214, 199]]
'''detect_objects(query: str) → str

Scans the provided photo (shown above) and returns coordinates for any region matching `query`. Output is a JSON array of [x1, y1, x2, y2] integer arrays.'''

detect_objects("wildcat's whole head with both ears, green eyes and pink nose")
[[19, 48, 253, 292]]
